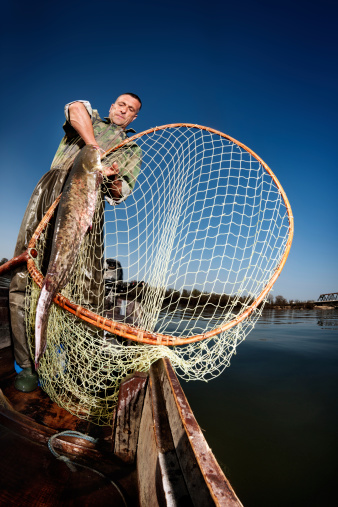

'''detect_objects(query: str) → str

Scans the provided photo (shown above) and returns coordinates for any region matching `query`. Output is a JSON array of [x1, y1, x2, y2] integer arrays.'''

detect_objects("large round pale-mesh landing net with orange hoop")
[[26, 125, 293, 424]]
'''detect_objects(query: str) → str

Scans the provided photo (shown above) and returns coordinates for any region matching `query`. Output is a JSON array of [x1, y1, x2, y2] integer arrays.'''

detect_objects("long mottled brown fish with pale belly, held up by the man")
[[35, 145, 102, 369]]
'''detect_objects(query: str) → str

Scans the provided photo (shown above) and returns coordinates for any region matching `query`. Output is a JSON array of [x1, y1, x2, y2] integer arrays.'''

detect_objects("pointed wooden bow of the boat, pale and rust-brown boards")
[[137, 359, 241, 506]]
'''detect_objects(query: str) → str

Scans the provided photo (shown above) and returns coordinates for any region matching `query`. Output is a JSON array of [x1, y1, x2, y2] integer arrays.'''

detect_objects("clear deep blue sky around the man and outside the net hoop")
[[0, 0, 338, 299]]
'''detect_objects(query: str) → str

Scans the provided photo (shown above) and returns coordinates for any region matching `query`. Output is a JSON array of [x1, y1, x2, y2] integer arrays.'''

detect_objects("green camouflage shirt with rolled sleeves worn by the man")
[[51, 101, 142, 205]]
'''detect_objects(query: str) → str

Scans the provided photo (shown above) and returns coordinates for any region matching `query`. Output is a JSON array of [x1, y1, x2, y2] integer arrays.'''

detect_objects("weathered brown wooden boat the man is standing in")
[[0, 287, 242, 507]]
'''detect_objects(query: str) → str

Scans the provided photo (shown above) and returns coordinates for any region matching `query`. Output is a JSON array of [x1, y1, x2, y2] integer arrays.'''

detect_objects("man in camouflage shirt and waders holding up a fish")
[[9, 93, 142, 392]]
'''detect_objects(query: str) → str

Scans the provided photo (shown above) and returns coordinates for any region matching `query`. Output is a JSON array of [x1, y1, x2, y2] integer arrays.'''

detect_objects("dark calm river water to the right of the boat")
[[181, 309, 338, 507]]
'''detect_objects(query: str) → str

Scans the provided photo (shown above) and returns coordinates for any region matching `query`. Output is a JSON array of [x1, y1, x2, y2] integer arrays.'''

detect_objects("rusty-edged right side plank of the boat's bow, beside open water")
[[160, 359, 242, 507]]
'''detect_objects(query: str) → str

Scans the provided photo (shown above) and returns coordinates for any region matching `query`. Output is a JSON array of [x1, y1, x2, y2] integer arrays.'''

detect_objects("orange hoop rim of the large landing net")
[[27, 123, 294, 346]]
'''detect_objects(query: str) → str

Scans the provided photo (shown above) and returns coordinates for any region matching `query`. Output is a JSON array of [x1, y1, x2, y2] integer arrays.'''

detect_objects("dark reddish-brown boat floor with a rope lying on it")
[[0, 347, 138, 507]]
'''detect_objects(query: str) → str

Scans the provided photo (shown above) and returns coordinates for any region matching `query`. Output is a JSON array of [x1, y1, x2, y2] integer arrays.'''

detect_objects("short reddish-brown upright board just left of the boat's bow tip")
[[113, 372, 148, 464]]
